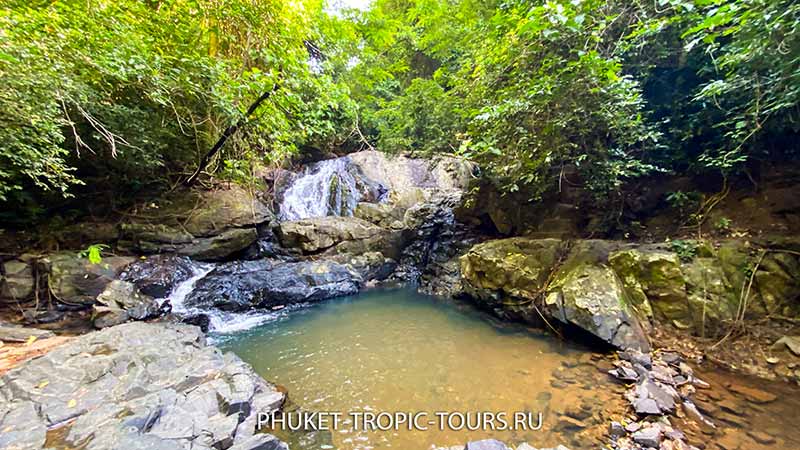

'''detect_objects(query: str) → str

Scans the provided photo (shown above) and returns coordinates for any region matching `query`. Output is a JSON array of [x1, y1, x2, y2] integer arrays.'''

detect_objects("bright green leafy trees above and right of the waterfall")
[[342, 0, 659, 197]]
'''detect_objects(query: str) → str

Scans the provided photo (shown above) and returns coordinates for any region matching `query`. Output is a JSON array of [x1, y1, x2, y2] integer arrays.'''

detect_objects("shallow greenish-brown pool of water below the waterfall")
[[221, 290, 616, 450]]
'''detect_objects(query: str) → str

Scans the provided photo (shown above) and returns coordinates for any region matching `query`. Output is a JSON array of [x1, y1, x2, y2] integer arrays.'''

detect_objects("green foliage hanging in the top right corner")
[[683, 0, 800, 172]]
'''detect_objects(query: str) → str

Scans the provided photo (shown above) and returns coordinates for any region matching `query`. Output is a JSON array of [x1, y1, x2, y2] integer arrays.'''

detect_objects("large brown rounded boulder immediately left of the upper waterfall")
[[120, 186, 274, 261]]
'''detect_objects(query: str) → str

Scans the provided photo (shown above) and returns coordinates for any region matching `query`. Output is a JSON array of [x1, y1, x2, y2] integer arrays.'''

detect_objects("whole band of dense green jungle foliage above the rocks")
[[0, 0, 800, 219]]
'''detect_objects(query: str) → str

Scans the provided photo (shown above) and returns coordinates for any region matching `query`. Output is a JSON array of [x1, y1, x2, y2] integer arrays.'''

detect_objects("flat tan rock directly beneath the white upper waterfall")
[[275, 216, 384, 253]]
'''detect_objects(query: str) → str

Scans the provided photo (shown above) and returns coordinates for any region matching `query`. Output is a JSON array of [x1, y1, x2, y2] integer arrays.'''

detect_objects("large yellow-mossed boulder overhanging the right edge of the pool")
[[461, 238, 649, 349]]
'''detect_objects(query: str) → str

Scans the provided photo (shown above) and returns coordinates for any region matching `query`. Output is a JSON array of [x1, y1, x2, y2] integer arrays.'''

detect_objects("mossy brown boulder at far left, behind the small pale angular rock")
[[41, 253, 134, 307]]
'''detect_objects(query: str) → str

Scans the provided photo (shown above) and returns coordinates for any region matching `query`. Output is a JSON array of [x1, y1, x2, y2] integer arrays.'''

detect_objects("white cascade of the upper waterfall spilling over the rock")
[[279, 157, 385, 220]]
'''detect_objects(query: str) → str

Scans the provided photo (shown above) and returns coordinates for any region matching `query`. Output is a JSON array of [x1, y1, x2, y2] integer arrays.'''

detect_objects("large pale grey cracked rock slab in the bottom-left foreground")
[[0, 322, 288, 450]]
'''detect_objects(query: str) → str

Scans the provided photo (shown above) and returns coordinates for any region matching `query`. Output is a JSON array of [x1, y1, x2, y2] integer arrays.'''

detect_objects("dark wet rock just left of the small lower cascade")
[[119, 255, 195, 298]]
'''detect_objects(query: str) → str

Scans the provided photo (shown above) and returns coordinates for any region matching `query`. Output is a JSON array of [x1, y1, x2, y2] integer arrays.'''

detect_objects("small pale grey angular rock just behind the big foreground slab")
[[93, 280, 159, 328]]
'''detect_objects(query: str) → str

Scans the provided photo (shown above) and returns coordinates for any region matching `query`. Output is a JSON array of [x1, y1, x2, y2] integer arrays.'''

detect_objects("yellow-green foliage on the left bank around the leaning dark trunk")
[[0, 0, 354, 209]]
